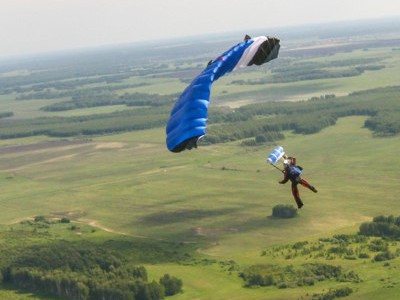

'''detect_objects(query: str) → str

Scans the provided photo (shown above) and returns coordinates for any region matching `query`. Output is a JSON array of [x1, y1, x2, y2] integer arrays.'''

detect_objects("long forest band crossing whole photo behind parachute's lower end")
[[0, 86, 400, 144]]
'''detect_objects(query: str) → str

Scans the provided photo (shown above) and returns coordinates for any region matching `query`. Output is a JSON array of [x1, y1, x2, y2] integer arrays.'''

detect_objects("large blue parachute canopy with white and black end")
[[166, 35, 280, 152]]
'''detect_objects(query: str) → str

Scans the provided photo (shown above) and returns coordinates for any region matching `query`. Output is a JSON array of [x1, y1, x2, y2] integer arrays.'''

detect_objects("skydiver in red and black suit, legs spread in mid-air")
[[279, 156, 318, 209]]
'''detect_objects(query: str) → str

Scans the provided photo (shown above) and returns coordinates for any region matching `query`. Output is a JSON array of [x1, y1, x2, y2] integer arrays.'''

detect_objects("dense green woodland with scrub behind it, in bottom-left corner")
[[0, 216, 182, 300]]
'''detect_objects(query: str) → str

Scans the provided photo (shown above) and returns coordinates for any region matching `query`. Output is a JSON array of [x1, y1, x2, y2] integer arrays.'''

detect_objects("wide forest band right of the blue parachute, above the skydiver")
[[204, 86, 400, 143]]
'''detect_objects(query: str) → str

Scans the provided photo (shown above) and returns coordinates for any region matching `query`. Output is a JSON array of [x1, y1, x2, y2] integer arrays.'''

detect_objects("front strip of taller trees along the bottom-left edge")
[[1, 267, 182, 300]]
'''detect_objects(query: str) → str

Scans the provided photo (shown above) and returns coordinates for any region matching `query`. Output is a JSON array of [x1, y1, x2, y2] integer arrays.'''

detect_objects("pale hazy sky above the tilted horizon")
[[0, 0, 400, 57]]
